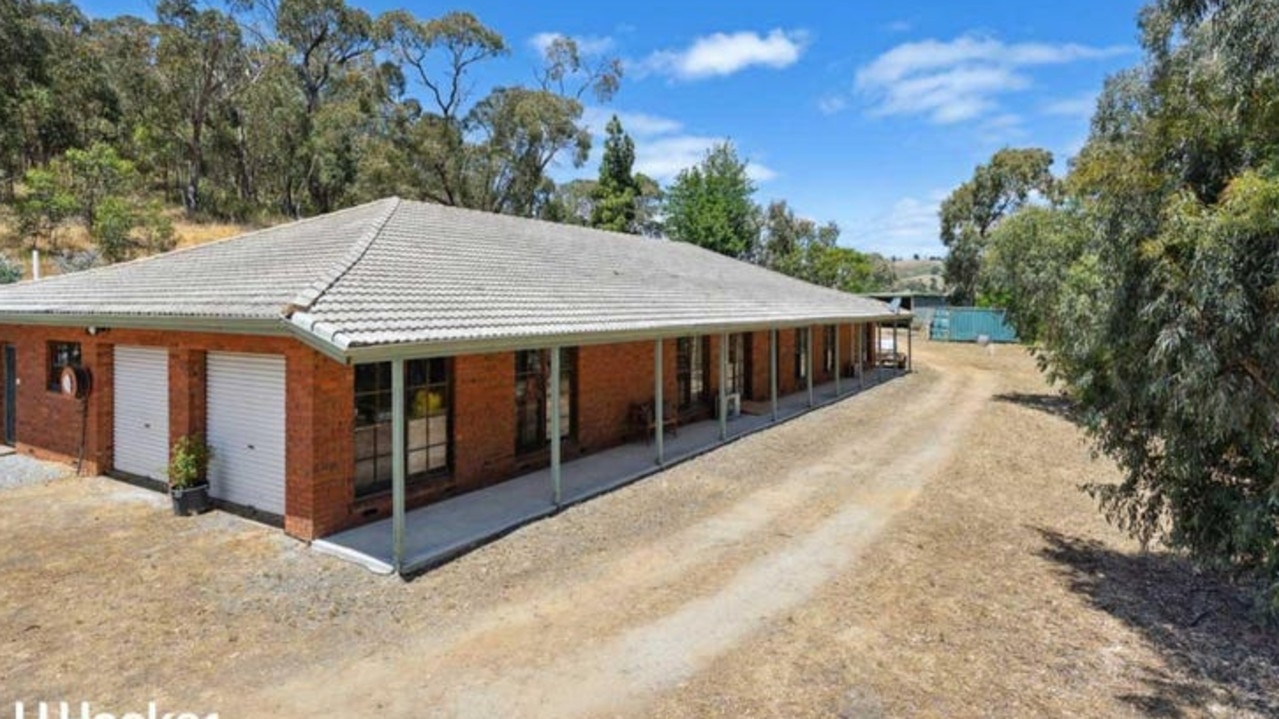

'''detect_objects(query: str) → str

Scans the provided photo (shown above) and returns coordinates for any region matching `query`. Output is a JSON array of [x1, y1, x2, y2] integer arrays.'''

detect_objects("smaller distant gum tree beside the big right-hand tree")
[[941, 148, 1055, 304]]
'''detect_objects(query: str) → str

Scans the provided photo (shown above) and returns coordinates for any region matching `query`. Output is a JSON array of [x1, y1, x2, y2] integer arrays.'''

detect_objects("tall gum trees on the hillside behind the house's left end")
[[0, 0, 622, 226]]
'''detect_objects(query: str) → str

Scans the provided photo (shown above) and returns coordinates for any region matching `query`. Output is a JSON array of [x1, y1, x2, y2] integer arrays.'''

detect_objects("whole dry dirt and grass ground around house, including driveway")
[[0, 342, 1279, 718]]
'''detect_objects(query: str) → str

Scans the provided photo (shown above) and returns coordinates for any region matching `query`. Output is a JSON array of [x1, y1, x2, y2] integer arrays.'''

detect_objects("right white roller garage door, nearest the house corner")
[[207, 352, 284, 516]]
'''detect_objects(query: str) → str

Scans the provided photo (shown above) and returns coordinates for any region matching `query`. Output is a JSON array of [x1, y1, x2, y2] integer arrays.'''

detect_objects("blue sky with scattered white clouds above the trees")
[[81, 0, 1142, 256]]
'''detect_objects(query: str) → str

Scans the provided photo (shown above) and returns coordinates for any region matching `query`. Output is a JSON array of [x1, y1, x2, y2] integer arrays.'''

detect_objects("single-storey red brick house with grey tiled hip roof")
[[0, 198, 895, 555]]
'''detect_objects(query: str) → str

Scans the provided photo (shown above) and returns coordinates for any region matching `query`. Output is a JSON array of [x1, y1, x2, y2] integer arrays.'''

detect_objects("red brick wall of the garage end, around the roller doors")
[[0, 325, 353, 539]]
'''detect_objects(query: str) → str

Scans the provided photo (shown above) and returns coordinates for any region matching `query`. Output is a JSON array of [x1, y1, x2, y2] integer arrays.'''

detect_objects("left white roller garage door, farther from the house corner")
[[113, 347, 169, 480]]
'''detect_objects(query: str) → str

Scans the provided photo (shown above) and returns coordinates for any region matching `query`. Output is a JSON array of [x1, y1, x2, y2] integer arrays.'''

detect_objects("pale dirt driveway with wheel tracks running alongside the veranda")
[[241, 372, 990, 716]]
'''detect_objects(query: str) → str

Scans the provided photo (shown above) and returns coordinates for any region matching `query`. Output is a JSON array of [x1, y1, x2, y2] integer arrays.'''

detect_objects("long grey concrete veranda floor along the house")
[[311, 367, 904, 574]]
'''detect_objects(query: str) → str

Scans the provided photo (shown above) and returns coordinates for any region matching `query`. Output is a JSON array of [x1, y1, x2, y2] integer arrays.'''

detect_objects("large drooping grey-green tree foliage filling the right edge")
[[984, 0, 1279, 617]]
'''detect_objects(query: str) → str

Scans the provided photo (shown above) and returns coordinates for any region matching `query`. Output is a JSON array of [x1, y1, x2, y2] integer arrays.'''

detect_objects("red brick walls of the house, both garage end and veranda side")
[[0, 325, 867, 539]]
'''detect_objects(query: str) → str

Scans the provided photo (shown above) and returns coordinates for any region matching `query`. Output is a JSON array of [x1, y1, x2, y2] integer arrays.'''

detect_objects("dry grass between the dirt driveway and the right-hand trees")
[[660, 344, 1279, 718]]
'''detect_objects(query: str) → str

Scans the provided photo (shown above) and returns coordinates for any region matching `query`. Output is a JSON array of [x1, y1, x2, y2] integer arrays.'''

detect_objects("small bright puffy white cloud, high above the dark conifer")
[[641, 28, 808, 79]]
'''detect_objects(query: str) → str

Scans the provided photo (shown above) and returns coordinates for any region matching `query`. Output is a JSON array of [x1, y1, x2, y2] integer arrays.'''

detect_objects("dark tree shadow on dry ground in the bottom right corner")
[[1036, 528, 1279, 716]]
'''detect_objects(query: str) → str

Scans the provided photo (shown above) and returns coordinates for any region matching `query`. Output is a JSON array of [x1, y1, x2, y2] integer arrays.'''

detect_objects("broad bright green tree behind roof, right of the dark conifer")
[[665, 142, 760, 260]]
